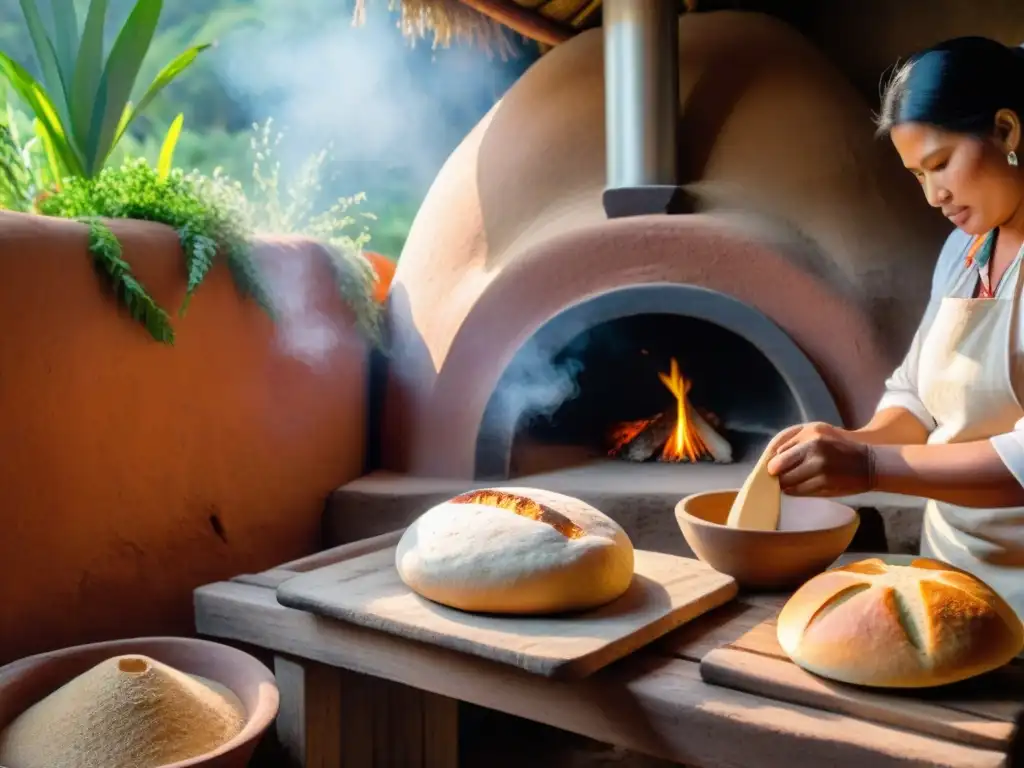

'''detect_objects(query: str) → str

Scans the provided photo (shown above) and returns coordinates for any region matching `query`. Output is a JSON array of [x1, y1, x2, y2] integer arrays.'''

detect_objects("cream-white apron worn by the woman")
[[918, 243, 1024, 618]]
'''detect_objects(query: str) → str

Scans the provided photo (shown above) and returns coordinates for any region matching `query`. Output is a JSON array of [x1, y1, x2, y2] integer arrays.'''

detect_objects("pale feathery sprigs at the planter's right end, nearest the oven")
[[191, 120, 381, 344]]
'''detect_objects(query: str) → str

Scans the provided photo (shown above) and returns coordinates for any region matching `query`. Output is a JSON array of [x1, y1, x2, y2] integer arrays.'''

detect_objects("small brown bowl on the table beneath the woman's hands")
[[676, 490, 860, 590]]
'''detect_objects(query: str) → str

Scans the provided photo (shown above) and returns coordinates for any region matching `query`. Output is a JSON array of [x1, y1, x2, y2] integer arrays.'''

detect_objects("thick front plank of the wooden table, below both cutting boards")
[[196, 582, 1006, 768]]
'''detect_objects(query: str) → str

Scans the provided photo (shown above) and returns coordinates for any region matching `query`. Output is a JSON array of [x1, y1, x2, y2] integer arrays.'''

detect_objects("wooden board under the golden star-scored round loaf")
[[700, 616, 1024, 751]]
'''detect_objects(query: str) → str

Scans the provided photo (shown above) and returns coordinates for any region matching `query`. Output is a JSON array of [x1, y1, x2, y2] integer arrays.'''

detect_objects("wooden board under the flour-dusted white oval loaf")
[[278, 546, 737, 678]]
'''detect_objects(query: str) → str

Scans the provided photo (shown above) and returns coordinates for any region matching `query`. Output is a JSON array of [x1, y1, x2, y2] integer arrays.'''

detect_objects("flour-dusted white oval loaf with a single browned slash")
[[395, 487, 633, 614]]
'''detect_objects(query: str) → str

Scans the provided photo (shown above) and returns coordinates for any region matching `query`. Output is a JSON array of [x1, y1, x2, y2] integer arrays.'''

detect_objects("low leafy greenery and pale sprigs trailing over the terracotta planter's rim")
[[6, 122, 382, 345]]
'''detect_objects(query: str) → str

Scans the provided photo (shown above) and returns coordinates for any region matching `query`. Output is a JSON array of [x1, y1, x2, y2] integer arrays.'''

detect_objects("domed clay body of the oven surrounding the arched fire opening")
[[384, 11, 948, 477]]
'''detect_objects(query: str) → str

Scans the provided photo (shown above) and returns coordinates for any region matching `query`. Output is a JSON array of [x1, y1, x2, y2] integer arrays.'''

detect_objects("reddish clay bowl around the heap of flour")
[[0, 637, 280, 768]]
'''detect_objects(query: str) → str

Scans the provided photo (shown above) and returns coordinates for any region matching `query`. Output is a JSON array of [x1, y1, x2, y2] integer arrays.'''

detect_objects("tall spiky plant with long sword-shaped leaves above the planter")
[[0, 0, 209, 181]]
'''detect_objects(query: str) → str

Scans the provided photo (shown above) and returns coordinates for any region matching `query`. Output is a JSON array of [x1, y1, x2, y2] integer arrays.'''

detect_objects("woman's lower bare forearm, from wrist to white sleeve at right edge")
[[872, 440, 1024, 508]]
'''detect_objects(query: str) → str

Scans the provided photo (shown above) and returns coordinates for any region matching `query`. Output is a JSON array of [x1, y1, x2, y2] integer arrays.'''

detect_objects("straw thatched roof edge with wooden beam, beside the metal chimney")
[[355, 0, 696, 56]]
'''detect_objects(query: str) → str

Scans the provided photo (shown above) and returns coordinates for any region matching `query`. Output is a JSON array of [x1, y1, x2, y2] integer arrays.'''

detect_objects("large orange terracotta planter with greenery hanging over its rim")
[[0, 212, 368, 664]]
